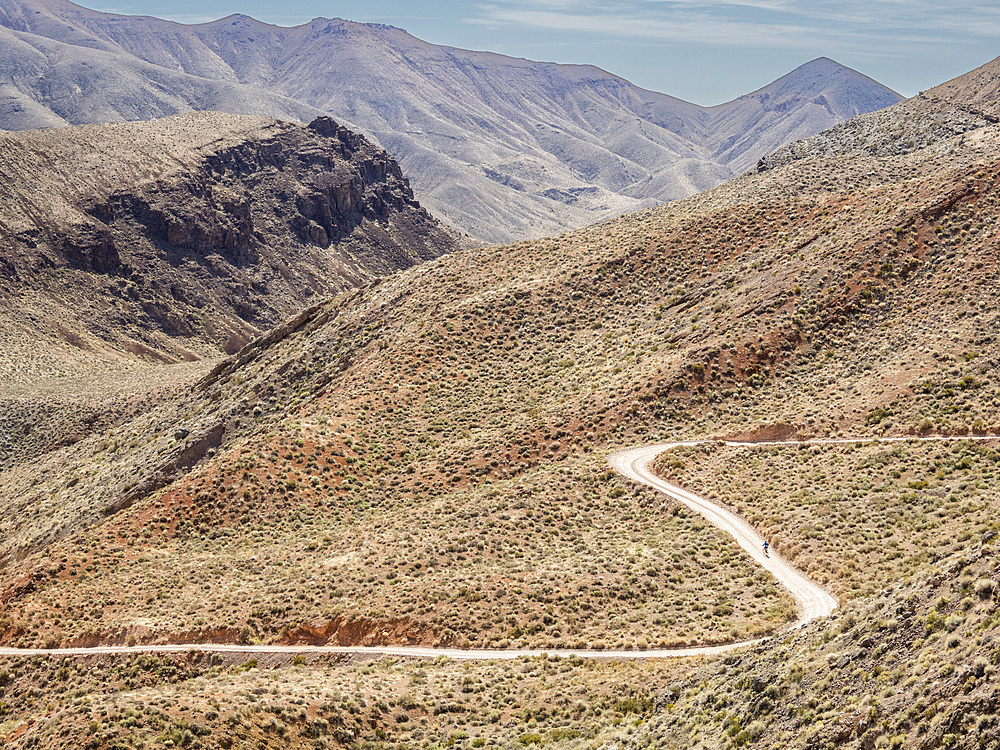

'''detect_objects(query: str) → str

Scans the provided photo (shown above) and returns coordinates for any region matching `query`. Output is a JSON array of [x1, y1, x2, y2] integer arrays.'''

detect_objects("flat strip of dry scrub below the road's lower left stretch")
[[0, 656, 697, 748]]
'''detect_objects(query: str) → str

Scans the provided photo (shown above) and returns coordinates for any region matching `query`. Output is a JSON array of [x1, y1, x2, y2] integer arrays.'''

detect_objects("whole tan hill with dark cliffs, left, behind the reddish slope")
[[0, 113, 458, 382]]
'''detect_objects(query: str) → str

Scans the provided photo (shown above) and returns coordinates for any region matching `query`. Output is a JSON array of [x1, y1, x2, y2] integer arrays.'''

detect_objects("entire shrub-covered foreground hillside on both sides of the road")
[[0, 51, 1000, 749]]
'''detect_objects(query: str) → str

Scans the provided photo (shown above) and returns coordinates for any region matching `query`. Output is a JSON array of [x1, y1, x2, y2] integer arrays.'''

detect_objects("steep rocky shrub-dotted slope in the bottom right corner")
[[623, 528, 1000, 750]]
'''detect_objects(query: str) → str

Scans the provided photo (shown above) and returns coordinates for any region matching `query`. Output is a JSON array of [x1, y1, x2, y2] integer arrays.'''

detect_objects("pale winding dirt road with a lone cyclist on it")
[[0, 436, 1000, 660]]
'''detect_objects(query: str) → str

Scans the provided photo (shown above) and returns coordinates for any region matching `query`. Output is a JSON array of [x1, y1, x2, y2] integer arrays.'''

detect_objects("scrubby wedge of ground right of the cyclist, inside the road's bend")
[[656, 441, 1000, 598]]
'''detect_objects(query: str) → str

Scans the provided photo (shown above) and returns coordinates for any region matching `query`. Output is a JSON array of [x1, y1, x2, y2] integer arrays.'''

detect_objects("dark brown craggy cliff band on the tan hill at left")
[[85, 117, 442, 271]]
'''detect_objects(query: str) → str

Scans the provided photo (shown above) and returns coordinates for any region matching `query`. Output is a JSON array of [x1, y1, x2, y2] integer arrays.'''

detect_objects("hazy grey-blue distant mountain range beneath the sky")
[[0, 0, 900, 242]]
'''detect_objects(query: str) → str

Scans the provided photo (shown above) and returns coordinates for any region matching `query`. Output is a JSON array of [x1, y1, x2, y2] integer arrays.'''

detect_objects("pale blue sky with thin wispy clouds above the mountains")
[[92, 0, 1000, 104]]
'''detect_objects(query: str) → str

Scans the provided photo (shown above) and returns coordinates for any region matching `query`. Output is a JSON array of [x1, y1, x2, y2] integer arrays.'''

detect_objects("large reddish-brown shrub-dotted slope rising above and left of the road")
[[0, 53, 1000, 664]]
